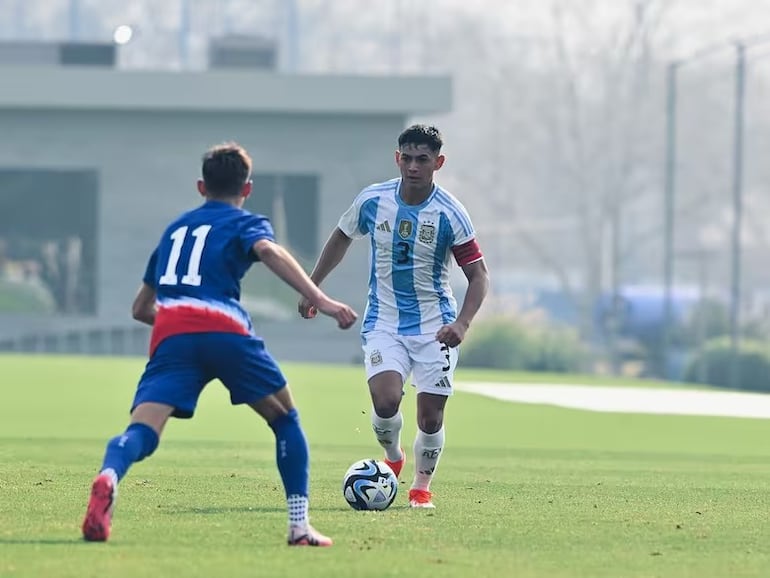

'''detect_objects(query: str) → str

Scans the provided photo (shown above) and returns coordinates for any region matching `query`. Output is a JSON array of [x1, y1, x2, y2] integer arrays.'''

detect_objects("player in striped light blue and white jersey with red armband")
[[299, 124, 489, 508]]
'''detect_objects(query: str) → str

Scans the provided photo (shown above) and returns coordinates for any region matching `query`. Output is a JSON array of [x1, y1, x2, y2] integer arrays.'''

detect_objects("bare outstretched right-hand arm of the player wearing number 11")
[[253, 239, 358, 329]]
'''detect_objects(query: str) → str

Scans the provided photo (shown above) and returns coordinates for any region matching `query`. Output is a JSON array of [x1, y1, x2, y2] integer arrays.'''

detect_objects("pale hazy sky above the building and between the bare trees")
[[0, 0, 770, 288]]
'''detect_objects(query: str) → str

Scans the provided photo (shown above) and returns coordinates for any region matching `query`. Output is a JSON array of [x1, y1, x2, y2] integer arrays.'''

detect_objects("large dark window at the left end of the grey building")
[[0, 169, 99, 315]]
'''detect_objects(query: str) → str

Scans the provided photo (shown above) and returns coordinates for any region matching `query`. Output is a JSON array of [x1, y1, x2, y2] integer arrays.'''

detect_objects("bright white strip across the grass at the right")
[[455, 382, 770, 419]]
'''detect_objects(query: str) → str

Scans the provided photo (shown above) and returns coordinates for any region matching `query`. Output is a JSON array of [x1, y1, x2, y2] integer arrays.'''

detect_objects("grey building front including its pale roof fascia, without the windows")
[[0, 66, 451, 361]]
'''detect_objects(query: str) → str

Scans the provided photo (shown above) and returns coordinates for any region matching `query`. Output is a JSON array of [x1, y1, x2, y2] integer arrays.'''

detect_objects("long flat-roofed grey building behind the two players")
[[0, 41, 451, 361]]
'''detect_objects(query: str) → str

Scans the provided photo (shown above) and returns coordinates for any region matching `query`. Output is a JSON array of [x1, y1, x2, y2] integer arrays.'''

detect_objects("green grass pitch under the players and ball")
[[0, 356, 770, 578]]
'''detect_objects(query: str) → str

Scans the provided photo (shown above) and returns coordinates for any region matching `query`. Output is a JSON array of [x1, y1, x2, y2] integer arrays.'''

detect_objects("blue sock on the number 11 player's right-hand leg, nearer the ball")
[[270, 409, 310, 498]]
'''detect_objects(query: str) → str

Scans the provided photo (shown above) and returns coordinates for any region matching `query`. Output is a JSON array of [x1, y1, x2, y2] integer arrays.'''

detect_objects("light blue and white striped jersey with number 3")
[[337, 179, 483, 335]]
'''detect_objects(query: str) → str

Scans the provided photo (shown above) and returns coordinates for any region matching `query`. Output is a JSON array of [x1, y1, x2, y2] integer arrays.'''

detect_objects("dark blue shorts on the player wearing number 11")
[[131, 333, 286, 418]]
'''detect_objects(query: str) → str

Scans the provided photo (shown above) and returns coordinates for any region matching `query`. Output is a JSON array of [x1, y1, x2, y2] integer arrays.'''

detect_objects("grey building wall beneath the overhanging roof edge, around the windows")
[[0, 111, 405, 359]]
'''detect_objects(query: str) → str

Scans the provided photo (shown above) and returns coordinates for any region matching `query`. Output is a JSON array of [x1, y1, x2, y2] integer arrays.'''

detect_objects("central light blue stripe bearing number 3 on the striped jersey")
[[392, 205, 421, 335]]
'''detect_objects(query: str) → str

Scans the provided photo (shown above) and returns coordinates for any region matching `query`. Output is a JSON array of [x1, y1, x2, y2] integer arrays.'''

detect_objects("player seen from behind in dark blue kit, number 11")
[[82, 143, 357, 546]]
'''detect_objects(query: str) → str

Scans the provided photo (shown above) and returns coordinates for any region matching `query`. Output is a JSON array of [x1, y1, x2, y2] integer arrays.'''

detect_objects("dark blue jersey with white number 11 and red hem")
[[144, 201, 275, 354]]
